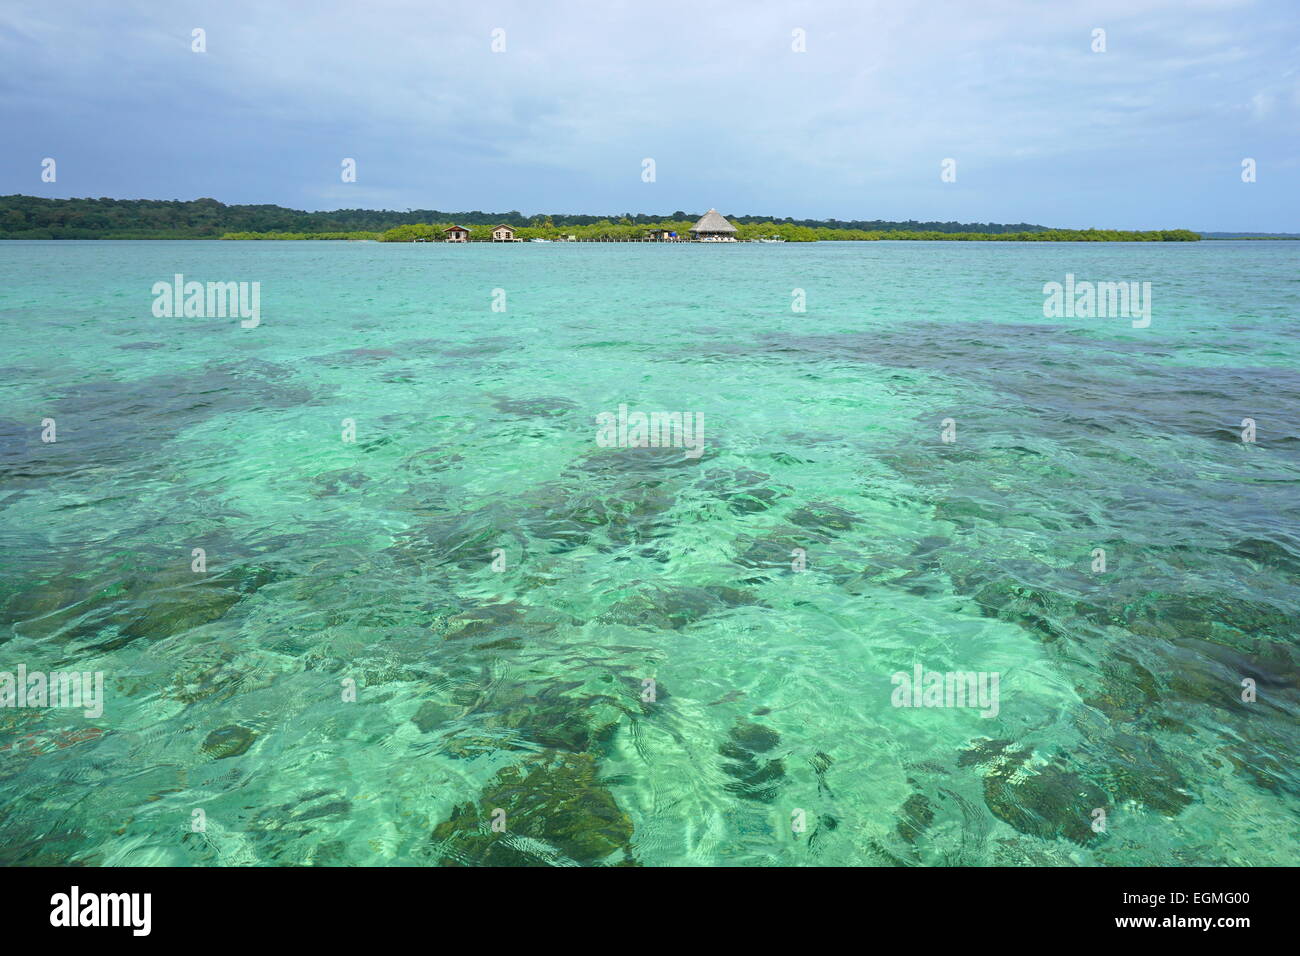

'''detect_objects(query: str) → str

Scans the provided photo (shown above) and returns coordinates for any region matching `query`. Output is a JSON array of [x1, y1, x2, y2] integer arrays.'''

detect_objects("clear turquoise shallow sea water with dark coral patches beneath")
[[0, 242, 1300, 865]]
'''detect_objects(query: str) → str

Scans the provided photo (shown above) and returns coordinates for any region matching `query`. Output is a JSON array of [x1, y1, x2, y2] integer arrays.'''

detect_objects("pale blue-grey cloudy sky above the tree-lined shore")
[[0, 0, 1300, 233]]
